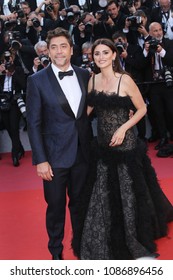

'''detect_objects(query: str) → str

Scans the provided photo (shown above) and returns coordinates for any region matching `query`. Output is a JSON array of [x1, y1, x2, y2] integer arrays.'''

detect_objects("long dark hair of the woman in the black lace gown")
[[92, 38, 127, 74]]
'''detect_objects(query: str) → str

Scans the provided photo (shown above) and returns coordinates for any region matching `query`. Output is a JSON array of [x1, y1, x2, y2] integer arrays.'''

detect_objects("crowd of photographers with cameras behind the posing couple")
[[0, 0, 173, 166]]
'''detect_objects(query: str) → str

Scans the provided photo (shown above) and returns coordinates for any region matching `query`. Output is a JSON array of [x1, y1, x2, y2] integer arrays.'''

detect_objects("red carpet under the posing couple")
[[0, 145, 173, 260]]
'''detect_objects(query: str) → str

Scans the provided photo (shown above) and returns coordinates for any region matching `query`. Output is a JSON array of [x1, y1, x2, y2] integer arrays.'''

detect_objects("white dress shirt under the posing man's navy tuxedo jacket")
[[51, 63, 82, 117]]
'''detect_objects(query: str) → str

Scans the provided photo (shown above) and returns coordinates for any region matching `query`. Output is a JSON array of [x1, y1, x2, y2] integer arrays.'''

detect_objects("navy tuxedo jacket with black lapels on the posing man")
[[26, 65, 90, 168]]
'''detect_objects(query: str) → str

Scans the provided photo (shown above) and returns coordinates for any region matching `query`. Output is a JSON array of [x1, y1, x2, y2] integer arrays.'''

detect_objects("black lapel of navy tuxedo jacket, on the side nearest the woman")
[[73, 65, 86, 119]]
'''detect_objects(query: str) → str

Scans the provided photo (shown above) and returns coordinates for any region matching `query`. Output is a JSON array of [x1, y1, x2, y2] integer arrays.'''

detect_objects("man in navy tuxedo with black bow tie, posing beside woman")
[[26, 28, 90, 259]]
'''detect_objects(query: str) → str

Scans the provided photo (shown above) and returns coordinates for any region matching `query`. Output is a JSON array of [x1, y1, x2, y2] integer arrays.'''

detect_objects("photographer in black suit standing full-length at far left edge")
[[0, 51, 26, 166]]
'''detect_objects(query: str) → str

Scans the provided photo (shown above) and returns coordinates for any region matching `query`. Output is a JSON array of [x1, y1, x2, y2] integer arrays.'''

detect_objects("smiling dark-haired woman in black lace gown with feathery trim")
[[72, 39, 173, 260]]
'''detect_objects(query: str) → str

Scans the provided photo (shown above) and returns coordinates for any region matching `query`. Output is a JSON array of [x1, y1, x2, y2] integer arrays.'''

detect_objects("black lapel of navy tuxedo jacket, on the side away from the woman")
[[46, 65, 75, 118]]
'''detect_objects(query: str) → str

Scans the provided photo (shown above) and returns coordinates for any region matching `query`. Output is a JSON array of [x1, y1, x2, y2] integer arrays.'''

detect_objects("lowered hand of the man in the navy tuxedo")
[[37, 161, 54, 181]]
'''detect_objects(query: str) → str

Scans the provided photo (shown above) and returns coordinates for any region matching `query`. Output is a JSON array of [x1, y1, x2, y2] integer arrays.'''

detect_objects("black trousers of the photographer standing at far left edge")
[[1, 103, 22, 157]]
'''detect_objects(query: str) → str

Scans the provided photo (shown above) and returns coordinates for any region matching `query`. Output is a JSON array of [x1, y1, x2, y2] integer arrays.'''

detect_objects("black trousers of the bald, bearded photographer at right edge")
[[148, 83, 173, 138]]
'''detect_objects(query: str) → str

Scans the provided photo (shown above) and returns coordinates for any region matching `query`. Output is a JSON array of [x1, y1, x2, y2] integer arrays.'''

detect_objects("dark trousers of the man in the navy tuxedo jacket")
[[43, 148, 88, 255]]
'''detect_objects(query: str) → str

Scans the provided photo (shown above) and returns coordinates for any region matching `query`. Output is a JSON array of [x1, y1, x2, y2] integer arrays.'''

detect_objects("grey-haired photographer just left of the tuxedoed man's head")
[[32, 41, 49, 73]]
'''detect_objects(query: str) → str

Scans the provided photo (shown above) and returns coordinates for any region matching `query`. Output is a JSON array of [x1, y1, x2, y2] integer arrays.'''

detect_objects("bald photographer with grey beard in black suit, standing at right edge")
[[143, 22, 173, 150]]
